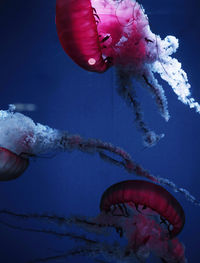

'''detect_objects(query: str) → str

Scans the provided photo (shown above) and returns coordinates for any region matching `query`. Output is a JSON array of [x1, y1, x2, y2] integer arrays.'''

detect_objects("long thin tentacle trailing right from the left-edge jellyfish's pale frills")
[[60, 134, 200, 206]]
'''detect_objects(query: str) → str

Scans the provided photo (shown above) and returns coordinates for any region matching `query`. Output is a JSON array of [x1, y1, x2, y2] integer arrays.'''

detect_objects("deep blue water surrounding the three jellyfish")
[[0, 0, 200, 263]]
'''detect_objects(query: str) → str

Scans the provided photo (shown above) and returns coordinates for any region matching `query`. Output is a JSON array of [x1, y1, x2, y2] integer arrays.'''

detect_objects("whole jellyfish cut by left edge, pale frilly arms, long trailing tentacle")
[[0, 104, 200, 205]]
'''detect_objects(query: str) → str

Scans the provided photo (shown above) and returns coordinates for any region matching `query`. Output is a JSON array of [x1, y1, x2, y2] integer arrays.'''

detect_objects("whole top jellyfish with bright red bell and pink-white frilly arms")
[[56, 0, 200, 146]]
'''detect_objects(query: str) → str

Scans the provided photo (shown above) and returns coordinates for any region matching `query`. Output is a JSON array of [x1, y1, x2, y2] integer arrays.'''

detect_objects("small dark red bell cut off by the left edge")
[[0, 147, 29, 181]]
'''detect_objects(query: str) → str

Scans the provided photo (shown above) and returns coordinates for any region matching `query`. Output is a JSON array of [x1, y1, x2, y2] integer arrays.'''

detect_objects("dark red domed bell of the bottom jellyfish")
[[100, 180, 185, 238]]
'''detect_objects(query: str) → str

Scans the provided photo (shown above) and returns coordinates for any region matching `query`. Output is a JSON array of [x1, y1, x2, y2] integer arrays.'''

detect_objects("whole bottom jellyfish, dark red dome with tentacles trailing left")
[[0, 180, 187, 263]]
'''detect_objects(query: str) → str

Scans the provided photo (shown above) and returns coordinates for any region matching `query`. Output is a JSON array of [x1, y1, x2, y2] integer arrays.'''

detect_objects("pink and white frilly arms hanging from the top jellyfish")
[[91, 0, 200, 147]]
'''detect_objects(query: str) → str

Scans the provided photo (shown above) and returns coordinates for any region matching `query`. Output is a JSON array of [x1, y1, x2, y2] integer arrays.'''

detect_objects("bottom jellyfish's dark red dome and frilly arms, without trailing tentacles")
[[96, 180, 186, 263]]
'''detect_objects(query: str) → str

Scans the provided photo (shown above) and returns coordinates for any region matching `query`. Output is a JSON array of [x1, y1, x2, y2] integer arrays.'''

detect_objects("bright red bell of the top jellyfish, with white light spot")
[[56, 0, 108, 72]]
